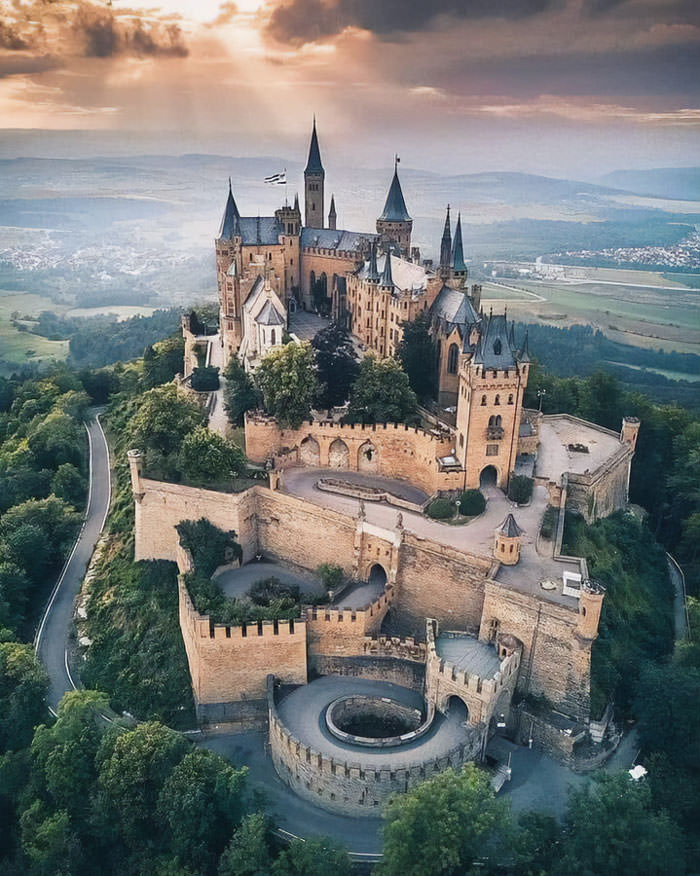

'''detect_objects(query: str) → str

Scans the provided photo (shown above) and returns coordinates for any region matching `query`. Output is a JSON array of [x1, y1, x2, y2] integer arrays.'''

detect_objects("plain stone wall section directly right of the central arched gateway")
[[394, 532, 493, 635]]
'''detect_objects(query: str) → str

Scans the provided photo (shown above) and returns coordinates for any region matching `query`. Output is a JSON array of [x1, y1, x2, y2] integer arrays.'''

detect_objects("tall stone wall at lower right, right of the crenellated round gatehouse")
[[479, 581, 591, 721]]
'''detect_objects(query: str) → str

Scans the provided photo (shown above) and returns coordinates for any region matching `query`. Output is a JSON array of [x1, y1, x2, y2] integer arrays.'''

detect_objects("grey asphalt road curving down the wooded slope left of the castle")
[[34, 418, 111, 713]]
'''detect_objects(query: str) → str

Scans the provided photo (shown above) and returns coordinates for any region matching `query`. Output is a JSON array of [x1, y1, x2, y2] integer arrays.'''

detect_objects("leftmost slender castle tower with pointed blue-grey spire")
[[215, 177, 243, 363]]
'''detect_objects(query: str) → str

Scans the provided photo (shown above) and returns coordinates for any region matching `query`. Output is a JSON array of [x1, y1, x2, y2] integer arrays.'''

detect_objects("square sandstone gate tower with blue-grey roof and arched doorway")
[[455, 314, 530, 490]]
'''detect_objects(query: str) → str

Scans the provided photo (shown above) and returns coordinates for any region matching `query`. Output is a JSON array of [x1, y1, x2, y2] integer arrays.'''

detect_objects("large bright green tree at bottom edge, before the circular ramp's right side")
[[379, 764, 509, 876]]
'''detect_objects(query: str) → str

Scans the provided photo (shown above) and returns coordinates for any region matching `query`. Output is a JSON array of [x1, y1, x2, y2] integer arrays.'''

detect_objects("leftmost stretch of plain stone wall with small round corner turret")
[[134, 478, 258, 562]]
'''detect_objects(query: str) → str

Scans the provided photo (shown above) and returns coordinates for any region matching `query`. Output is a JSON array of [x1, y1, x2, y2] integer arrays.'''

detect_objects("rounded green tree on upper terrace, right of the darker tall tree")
[[348, 356, 418, 423]]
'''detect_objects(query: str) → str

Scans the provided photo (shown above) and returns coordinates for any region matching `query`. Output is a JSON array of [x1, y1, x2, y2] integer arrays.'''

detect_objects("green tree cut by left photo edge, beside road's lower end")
[[0, 642, 48, 754]]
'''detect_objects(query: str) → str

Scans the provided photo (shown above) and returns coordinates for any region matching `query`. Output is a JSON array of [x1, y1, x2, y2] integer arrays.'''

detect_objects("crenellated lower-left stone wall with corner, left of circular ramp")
[[178, 575, 306, 713]]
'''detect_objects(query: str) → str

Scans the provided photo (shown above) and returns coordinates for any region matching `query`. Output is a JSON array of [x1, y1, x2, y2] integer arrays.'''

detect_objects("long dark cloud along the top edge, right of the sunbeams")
[[268, 0, 558, 44]]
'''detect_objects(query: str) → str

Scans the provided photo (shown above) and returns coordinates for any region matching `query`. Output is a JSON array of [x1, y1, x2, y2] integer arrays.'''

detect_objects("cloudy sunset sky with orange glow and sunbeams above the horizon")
[[0, 0, 700, 179]]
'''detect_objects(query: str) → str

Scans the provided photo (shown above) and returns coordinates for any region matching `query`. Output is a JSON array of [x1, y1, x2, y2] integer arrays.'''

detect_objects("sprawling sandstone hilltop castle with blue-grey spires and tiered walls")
[[134, 126, 640, 815]]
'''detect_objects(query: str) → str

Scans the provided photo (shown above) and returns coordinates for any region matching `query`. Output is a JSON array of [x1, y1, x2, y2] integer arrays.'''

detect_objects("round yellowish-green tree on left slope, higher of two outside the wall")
[[127, 383, 206, 456]]
